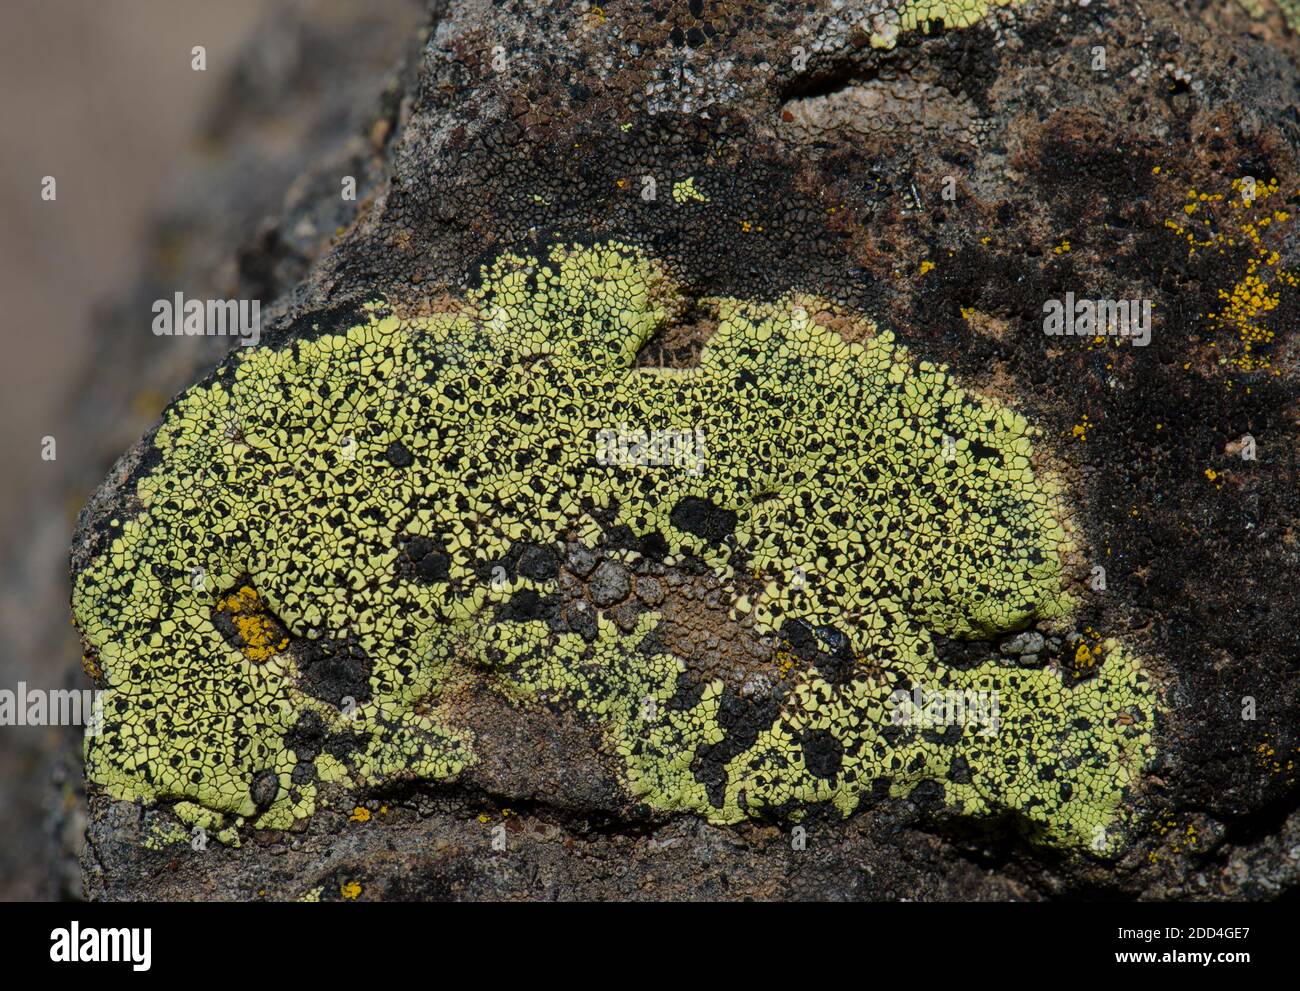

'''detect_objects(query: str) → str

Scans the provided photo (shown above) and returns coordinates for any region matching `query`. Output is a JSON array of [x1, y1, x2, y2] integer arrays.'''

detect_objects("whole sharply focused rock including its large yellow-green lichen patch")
[[73, 0, 1300, 899]]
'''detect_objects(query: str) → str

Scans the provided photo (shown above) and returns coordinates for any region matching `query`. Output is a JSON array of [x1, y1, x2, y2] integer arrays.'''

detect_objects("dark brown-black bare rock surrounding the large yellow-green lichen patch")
[[74, 0, 1300, 899]]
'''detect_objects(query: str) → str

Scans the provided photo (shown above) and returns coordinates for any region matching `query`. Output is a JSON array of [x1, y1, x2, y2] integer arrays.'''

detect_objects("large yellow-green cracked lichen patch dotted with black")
[[74, 243, 1154, 852]]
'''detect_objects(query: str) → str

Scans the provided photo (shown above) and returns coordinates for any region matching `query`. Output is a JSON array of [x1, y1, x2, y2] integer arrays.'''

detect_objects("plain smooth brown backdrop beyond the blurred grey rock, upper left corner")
[[0, 0, 268, 533]]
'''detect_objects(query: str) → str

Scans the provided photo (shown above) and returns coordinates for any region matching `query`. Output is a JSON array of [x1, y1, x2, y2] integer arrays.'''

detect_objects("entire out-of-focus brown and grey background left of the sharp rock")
[[0, 0, 426, 899]]
